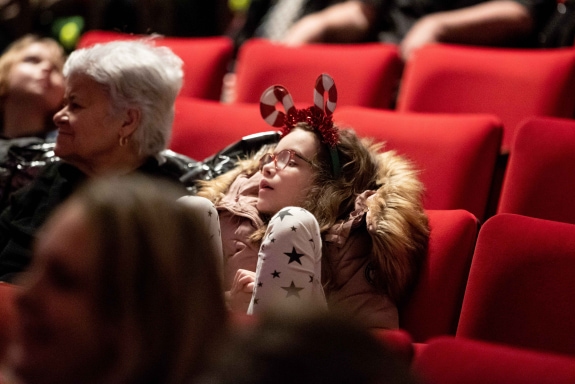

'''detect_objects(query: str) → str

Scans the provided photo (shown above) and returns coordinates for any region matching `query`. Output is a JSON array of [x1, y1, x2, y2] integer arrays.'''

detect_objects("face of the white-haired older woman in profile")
[[54, 75, 124, 165]]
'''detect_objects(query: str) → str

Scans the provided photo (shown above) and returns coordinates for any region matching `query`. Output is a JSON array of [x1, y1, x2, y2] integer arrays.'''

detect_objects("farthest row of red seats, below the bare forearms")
[[78, 30, 575, 152]]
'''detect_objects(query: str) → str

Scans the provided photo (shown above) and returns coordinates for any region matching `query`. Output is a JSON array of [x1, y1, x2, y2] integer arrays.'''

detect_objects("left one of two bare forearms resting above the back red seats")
[[282, 0, 376, 46]]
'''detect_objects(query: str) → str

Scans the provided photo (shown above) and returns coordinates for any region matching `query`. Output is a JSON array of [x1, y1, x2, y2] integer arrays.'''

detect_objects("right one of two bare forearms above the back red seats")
[[400, 0, 534, 60]]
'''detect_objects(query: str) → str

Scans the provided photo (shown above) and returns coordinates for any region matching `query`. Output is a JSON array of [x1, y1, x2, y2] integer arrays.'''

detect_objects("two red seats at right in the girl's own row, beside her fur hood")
[[414, 210, 575, 355]]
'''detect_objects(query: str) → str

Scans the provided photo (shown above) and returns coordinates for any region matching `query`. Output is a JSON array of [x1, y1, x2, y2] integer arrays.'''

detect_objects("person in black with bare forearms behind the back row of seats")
[[282, 0, 555, 60]]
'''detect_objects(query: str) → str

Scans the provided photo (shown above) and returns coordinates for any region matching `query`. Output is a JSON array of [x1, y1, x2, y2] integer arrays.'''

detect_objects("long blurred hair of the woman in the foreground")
[[71, 176, 227, 384]]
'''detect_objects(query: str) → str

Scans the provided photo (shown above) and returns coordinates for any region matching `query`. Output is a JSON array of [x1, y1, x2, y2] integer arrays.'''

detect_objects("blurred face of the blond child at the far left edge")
[[8, 42, 64, 111]]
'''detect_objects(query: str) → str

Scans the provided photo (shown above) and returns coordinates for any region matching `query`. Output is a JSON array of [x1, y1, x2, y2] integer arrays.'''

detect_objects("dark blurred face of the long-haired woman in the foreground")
[[8, 203, 116, 383]]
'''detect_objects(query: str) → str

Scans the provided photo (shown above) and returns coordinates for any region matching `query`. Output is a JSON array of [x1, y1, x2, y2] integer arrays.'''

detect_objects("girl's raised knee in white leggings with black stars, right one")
[[248, 207, 327, 314]]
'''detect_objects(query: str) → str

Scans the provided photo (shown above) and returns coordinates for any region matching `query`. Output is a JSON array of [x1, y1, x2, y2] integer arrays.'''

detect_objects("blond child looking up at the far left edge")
[[0, 35, 65, 207]]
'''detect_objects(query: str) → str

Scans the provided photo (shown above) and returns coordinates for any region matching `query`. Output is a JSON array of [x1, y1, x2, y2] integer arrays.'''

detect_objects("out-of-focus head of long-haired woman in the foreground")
[[0, 176, 227, 384]]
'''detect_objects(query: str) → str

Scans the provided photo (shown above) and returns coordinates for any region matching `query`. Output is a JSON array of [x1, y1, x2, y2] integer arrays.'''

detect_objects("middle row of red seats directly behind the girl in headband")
[[170, 99, 575, 228]]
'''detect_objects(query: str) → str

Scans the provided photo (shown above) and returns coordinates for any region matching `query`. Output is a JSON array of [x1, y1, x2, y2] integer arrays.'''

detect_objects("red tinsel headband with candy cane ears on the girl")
[[260, 73, 341, 177]]
